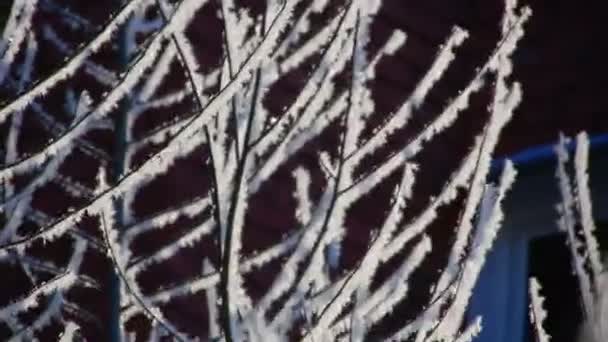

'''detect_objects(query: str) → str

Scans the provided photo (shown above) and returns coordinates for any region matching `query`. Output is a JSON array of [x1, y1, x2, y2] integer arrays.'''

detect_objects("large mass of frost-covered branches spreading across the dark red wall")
[[0, 0, 528, 342]]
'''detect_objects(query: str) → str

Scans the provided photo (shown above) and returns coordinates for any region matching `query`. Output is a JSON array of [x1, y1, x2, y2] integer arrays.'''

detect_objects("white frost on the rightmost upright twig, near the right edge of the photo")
[[574, 133, 603, 284]]
